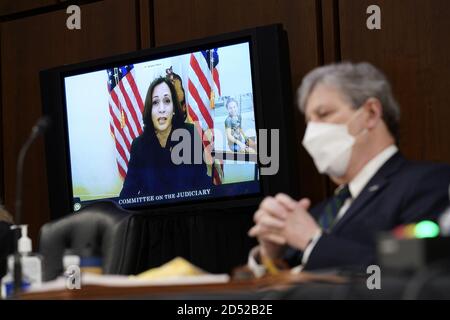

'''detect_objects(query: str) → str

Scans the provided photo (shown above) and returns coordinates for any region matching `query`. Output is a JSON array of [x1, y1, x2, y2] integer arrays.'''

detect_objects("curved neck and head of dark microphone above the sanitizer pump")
[[15, 116, 51, 225]]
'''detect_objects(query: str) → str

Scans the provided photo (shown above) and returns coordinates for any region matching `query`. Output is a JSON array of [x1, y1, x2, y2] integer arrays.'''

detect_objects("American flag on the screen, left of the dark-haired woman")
[[106, 65, 144, 179]]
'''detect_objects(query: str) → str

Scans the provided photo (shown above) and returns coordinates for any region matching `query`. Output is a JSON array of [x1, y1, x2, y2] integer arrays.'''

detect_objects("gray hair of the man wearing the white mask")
[[297, 62, 400, 138]]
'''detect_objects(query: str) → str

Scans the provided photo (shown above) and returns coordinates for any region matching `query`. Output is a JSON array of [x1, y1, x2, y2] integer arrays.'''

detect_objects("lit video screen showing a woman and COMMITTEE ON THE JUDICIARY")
[[64, 42, 261, 211]]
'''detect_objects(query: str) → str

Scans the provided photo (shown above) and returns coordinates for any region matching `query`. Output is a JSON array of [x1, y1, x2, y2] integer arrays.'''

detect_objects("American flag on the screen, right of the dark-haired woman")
[[188, 49, 223, 185]]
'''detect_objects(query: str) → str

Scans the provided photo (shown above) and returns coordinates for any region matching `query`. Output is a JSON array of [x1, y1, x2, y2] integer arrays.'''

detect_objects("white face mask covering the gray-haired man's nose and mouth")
[[302, 110, 366, 177]]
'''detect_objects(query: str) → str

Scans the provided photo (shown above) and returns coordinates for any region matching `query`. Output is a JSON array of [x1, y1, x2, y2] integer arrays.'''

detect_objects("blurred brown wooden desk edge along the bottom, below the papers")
[[16, 273, 450, 300]]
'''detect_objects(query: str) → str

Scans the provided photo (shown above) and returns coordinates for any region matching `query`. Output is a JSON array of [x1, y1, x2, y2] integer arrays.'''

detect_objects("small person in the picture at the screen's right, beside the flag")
[[225, 98, 256, 153]]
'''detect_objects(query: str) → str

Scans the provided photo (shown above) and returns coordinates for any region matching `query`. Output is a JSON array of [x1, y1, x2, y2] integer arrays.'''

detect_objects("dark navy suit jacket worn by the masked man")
[[285, 153, 450, 269]]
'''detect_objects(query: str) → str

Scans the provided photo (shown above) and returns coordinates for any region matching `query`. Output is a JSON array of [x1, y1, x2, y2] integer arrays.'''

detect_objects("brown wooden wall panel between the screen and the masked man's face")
[[154, 0, 326, 202]]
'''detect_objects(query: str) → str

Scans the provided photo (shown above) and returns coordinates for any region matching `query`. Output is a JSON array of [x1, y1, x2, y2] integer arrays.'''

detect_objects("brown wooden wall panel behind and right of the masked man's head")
[[339, 0, 450, 163]]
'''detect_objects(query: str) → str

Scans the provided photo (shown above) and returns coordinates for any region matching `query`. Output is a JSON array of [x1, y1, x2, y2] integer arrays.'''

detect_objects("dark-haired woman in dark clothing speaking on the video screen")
[[120, 77, 212, 198]]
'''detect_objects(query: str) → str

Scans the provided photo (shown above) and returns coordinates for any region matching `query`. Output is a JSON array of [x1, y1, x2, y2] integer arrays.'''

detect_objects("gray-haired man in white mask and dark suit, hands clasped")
[[249, 63, 450, 272]]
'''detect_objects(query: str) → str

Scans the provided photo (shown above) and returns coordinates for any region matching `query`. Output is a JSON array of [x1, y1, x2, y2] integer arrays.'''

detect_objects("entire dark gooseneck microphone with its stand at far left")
[[12, 116, 50, 296]]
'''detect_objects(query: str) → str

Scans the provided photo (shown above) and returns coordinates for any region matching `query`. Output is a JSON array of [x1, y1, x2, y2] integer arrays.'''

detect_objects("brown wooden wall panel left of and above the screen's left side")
[[0, 0, 139, 238]]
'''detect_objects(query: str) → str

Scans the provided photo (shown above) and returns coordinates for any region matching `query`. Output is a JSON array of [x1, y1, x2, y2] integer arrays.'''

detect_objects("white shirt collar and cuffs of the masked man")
[[248, 145, 398, 276]]
